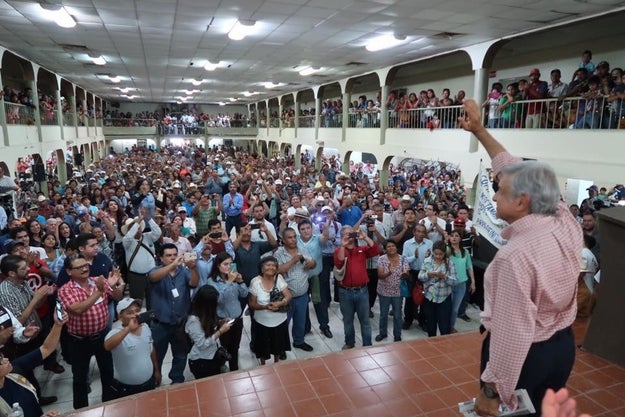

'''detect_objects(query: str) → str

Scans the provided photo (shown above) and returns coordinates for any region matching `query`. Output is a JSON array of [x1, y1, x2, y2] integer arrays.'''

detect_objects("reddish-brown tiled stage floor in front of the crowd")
[[63, 316, 625, 417]]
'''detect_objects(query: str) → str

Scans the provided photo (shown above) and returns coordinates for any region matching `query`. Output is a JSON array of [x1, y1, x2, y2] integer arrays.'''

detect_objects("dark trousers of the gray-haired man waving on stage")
[[480, 326, 575, 417]]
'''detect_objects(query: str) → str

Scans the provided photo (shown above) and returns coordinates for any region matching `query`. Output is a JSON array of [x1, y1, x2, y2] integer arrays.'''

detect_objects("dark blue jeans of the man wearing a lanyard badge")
[[150, 321, 187, 384]]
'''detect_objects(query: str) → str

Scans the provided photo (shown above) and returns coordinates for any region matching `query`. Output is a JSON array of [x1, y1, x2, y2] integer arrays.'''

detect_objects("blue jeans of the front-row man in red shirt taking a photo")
[[339, 286, 371, 346]]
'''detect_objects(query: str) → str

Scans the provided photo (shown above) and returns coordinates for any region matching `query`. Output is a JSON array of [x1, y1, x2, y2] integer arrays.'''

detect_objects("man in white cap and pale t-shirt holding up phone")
[[104, 297, 161, 398]]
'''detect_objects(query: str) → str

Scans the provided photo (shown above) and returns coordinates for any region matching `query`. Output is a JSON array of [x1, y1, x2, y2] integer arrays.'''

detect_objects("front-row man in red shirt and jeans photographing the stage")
[[334, 226, 380, 349]]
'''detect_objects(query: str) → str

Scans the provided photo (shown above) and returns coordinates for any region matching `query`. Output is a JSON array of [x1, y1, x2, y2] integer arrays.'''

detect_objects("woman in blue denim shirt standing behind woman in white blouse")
[[205, 252, 248, 371]]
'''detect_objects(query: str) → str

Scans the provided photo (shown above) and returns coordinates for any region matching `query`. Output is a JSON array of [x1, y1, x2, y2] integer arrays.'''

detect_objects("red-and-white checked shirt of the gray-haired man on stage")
[[481, 152, 583, 407]]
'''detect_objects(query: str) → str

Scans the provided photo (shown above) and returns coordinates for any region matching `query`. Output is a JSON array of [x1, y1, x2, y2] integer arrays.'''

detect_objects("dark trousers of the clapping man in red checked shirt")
[[69, 331, 115, 409]]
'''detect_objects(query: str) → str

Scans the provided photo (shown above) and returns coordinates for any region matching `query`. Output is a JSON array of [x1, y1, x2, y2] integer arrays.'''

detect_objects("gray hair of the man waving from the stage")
[[501, 161, 560, 215]]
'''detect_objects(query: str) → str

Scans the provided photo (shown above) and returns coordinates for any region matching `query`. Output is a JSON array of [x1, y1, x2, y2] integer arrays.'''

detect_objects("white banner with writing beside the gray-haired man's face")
[[473, 163, 508, 249]]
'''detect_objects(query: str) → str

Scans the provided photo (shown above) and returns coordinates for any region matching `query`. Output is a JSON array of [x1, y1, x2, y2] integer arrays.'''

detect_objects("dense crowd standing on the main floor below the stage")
[[0, 101, 625, 416]]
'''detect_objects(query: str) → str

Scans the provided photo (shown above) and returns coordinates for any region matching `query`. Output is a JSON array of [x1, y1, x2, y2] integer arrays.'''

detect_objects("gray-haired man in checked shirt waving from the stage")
[[459, 100, 583, 416]]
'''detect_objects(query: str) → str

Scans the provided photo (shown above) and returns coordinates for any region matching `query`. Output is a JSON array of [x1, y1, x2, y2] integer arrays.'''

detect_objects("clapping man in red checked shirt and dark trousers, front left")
[[55, 255, 124, 409]]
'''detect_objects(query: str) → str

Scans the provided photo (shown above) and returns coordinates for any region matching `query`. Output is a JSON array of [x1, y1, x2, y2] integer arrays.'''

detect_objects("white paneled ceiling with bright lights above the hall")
[[0, 0, 625, 103]]
